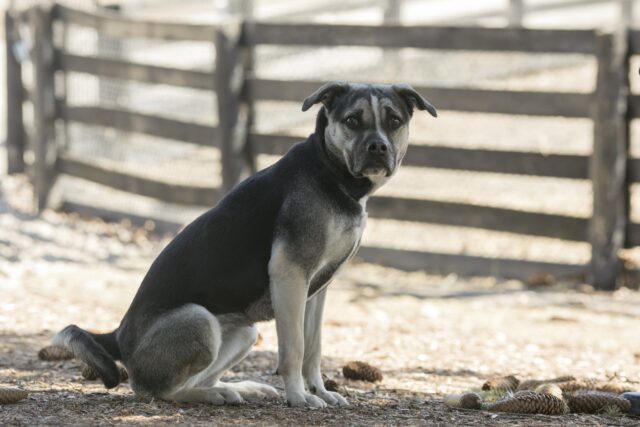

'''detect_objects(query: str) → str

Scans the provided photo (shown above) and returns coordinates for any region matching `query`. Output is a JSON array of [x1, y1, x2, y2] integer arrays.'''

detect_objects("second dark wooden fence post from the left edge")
[[29, 6, 56, 212]]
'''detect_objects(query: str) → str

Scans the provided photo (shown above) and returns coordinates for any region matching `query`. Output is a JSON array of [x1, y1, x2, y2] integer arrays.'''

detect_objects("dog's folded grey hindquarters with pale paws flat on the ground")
[[125, 304, 278, 405]]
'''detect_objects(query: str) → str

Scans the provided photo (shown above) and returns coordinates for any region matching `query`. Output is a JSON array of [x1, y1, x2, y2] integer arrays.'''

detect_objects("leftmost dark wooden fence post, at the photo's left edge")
[[4, 9, 24, 175]]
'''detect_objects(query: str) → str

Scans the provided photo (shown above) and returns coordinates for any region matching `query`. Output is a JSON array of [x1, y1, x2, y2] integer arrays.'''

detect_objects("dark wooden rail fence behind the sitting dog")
[[6, 6, 640, 289]]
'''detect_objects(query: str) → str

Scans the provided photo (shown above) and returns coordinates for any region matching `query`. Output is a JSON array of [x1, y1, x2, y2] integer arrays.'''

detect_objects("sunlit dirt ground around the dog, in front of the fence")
[[0, 177, 640, 426]]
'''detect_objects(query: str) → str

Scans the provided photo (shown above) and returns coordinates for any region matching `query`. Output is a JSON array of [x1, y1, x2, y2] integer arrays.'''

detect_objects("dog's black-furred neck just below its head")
[[310, 107, 375, 202]]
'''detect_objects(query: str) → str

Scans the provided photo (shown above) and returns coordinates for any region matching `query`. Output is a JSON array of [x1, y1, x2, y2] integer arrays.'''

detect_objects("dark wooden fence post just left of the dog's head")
[[215, 20, 253, 193]]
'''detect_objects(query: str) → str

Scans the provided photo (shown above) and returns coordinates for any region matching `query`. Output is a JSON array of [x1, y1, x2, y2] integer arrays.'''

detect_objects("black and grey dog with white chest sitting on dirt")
[[53, 81, 437, 408]]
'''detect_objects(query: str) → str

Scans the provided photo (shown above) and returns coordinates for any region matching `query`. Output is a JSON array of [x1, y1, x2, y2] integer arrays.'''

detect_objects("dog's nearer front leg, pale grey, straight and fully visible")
[[269, 246, 327, 408]]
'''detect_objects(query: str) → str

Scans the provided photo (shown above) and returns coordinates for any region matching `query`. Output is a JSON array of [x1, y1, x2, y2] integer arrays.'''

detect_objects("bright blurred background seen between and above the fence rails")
[[2, 0, 640, 274]]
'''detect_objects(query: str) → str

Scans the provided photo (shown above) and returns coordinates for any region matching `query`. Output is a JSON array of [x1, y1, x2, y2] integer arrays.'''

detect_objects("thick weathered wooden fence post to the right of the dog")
[[589, 31, 629, 290]]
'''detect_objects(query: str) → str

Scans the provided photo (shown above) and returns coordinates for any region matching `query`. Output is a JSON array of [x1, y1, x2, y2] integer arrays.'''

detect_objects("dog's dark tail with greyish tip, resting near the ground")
[[53, 325, 121, 388]]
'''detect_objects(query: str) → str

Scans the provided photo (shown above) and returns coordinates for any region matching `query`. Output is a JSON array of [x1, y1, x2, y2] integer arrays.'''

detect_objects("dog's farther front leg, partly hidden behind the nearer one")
[[302, 288, 348, 406]]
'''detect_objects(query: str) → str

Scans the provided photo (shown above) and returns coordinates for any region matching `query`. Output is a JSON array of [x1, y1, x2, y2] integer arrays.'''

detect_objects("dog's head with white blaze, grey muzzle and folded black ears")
[[302, 81, 437, 184]]
